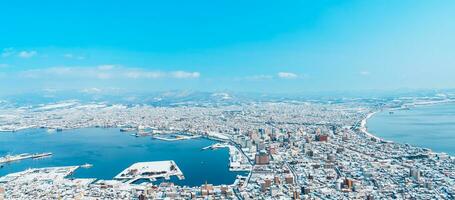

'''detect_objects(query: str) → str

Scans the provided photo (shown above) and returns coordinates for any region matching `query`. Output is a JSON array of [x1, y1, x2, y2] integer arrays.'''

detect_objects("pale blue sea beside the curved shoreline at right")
[[367, 103, 455, 155]]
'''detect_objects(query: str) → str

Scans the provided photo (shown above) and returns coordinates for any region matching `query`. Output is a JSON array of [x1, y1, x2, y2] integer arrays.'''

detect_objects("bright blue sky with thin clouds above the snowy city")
[[0, 0, 455, 95]]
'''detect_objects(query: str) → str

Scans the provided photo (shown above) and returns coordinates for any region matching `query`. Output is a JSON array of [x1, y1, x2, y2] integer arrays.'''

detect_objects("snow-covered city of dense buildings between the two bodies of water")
[[0, 93, 455, 199]]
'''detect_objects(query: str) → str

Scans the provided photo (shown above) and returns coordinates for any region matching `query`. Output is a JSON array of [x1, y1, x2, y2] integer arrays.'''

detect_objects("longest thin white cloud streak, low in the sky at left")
[[20, 65, 200, 80]]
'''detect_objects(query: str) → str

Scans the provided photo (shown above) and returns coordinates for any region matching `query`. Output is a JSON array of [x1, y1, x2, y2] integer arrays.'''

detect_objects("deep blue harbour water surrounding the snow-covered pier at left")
[[0, 128, 244, 186]]
